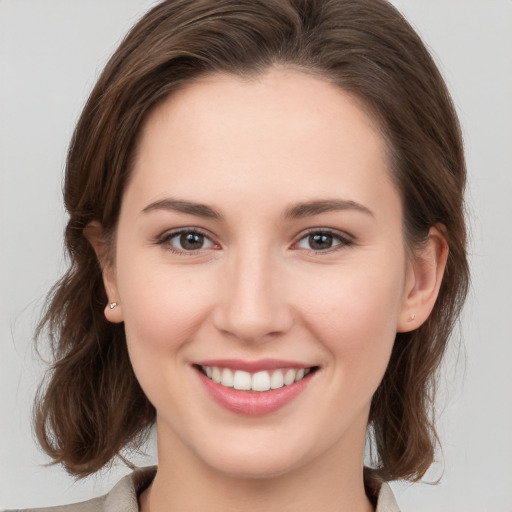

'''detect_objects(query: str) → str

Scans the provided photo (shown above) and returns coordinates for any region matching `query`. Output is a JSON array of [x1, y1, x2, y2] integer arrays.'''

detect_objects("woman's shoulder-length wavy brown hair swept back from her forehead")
[[35, 0, 469, 482]]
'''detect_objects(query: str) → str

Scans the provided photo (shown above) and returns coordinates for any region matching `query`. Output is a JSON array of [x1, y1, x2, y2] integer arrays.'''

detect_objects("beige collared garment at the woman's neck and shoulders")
[[5, 466, 400, 512]]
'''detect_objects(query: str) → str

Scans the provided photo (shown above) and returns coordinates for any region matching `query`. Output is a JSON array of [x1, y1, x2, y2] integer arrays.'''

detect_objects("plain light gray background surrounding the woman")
[[0, 0, 512, 512]]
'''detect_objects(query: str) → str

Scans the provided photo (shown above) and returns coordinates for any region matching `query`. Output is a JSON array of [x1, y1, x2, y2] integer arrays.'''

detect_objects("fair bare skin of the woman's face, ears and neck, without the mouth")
[[87, 69, 447, 512]]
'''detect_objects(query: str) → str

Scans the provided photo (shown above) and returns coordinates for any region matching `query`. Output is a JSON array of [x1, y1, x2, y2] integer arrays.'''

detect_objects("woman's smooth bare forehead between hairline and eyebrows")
[[126, 69, 398, 216]]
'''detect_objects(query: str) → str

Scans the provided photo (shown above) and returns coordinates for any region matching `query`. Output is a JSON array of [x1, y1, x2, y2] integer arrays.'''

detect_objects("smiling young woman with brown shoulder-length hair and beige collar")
[[11, 0, 468, 512]]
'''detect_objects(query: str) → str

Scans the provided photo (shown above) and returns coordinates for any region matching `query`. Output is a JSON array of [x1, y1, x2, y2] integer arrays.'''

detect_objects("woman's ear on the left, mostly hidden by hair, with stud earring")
[[84, 221, 124, 323]]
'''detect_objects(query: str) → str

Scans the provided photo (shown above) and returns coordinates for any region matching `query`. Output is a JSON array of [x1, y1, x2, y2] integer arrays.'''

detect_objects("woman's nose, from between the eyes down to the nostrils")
[[214, 249, 292, 342]]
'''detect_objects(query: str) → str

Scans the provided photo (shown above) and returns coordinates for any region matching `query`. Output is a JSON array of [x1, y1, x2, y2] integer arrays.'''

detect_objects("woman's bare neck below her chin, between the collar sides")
[[140, 420, 374, 512]]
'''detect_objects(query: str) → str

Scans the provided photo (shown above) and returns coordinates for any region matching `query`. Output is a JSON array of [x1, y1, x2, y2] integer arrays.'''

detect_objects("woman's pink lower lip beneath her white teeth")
[[197, 370, 313, 416]]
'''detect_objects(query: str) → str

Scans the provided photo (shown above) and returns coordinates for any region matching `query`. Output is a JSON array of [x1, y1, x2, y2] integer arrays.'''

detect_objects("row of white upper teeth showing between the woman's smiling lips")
[[196, 365, 318, 393]]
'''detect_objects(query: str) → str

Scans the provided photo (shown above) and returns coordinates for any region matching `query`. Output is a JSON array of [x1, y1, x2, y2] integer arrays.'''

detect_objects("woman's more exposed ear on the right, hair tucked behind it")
[[396, 226, 448, 332]]
